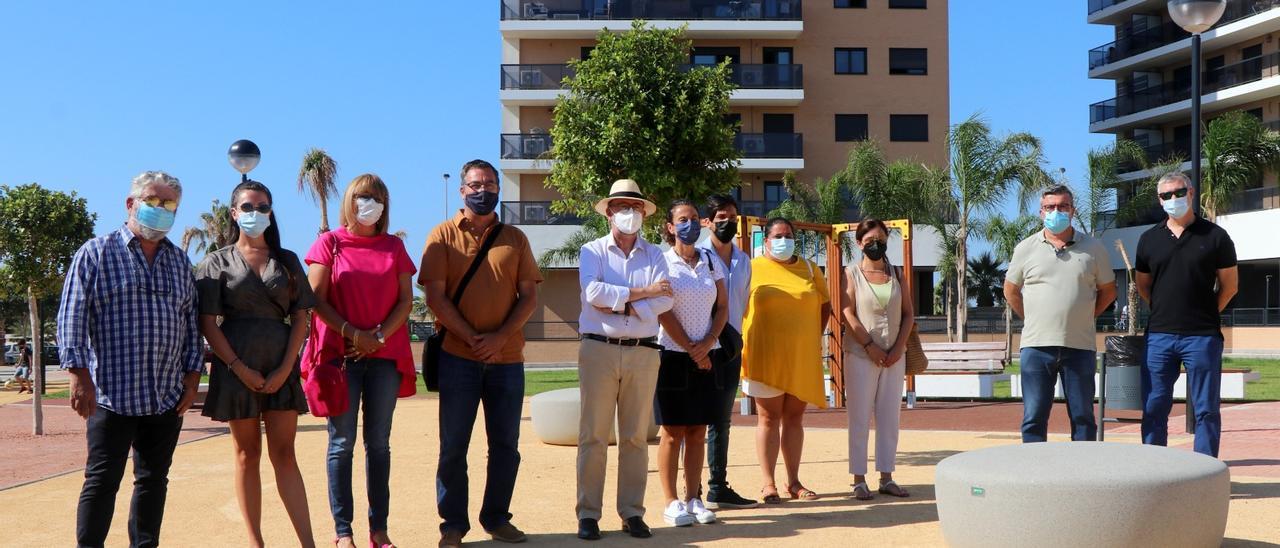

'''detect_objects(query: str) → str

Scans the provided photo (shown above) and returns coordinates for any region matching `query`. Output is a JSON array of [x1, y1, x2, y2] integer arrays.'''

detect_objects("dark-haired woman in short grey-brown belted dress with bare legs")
[[196, 181, 315, 547]]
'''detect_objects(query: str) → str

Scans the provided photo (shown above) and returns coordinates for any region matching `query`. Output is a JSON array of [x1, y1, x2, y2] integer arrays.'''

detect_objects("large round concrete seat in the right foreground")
[[936, 442, 1231, 548]]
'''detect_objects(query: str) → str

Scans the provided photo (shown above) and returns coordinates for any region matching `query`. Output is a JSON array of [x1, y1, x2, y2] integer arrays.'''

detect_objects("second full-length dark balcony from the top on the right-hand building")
[[1089, 52, 1280, 133]]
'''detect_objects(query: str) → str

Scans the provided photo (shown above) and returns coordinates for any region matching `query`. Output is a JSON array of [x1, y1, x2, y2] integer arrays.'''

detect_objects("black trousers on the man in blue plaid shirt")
[[76, 407, 182, 547]]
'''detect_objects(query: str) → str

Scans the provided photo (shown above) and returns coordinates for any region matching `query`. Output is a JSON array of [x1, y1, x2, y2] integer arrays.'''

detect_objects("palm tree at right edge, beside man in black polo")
[[1199, 110, 1280, 220]]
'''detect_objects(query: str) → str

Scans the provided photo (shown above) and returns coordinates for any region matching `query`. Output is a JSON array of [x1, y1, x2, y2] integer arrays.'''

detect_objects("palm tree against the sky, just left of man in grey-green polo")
[[947, 115, 1050, 342]]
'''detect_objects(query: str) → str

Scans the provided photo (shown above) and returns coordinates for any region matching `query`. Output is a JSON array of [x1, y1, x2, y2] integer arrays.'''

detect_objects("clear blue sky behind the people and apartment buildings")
[[0, 0, 1112, 263]]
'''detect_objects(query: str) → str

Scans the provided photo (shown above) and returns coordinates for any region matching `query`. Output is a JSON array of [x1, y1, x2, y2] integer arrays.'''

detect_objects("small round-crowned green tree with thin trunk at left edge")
[[0, 183, 97, 435]]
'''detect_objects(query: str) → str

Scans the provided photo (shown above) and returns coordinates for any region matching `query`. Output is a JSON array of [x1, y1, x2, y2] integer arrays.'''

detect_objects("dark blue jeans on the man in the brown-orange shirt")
[[435, 352, 525, 534]]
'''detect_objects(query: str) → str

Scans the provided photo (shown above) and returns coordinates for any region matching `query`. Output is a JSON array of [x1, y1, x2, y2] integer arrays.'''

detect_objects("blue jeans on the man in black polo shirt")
[[1142, 333, 1222, 457]]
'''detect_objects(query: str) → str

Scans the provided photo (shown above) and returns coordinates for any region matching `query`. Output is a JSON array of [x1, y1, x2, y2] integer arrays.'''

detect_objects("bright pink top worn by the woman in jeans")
[[302, 228, 417, 397]]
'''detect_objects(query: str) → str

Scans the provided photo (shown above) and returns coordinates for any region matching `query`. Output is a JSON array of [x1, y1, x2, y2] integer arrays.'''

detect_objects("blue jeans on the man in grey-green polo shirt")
[[1021, 346, 1098, 443]]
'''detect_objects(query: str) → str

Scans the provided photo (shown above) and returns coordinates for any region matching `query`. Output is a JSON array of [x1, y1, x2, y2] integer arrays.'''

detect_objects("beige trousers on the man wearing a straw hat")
[[577, 339, 658, 520]]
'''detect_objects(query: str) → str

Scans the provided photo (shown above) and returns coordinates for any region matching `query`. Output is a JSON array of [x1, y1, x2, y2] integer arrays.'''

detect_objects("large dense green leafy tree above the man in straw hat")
[[541, 20, 740, 264]]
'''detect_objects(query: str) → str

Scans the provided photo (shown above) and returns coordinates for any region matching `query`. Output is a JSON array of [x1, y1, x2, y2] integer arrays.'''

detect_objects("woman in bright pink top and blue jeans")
[[302, 173, 417, 547]]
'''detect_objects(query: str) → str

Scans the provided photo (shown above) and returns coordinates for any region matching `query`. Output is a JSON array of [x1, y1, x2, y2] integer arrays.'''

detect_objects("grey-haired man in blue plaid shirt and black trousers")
[[58, 172, 204, 547]]
